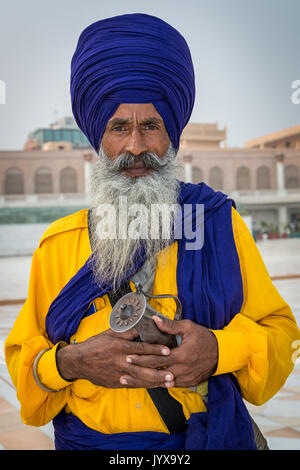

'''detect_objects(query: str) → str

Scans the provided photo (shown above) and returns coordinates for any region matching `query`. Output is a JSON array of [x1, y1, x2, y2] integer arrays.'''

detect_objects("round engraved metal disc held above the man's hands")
[[109, 292, 146, 333]]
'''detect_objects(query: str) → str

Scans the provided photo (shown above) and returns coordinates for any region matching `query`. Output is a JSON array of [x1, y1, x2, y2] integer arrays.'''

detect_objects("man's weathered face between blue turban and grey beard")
[[101, 103, 170, 178]]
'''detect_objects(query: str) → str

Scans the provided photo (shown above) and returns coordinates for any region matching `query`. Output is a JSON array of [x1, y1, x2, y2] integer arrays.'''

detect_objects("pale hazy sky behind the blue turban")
[[0, 0, 300, 150]]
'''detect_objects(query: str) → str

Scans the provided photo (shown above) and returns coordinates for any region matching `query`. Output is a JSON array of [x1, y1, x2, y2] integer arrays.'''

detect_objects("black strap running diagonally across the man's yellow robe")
[[108, 282, 187, 433]]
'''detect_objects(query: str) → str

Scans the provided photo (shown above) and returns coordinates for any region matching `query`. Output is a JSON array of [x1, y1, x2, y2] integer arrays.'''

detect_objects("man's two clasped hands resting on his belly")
[[57, 316, 218, 388]]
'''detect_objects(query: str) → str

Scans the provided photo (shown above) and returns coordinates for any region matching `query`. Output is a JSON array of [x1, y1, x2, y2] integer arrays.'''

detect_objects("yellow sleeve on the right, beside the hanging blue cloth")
[[212, 209, 300, 405]]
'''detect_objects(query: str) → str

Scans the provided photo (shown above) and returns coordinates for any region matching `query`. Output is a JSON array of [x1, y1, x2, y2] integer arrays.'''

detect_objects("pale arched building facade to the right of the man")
[[180, 148, 300, 237]]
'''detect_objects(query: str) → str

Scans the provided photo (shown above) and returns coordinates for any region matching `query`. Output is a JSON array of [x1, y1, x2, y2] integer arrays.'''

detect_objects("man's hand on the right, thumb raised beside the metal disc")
[[124, 316, 218, 387]]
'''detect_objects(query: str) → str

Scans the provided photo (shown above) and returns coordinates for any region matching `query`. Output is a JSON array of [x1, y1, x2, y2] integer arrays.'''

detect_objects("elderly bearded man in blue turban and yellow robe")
[[6, 14, 299, 449]]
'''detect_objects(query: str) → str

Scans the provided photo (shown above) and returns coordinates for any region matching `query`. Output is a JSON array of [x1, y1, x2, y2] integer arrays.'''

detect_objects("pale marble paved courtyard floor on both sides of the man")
[[0, 239, 300, 450]]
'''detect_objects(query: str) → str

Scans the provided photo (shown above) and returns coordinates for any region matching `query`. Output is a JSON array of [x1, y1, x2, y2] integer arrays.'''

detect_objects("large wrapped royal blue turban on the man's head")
[[70, 13, 195, 152]]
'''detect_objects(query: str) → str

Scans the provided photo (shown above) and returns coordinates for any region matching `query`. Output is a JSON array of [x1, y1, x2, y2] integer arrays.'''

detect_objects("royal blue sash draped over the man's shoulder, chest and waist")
[[46, 182, 256, 450]]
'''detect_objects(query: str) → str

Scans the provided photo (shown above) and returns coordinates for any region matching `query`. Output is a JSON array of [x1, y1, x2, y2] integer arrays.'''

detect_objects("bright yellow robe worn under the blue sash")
[[5, 209, 300, 433]]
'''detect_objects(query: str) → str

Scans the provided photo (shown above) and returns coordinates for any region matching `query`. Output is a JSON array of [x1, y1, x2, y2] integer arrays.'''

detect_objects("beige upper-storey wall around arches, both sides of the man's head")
[[0, 148, 300, 195]]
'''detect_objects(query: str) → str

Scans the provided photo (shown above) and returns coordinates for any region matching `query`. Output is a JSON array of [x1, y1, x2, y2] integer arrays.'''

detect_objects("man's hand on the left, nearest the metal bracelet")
[[56, 329, 174, 388]]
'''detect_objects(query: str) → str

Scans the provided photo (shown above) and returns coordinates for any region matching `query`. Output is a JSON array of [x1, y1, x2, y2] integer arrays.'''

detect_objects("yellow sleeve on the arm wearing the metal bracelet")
[[5, 248, 70, 426]]
